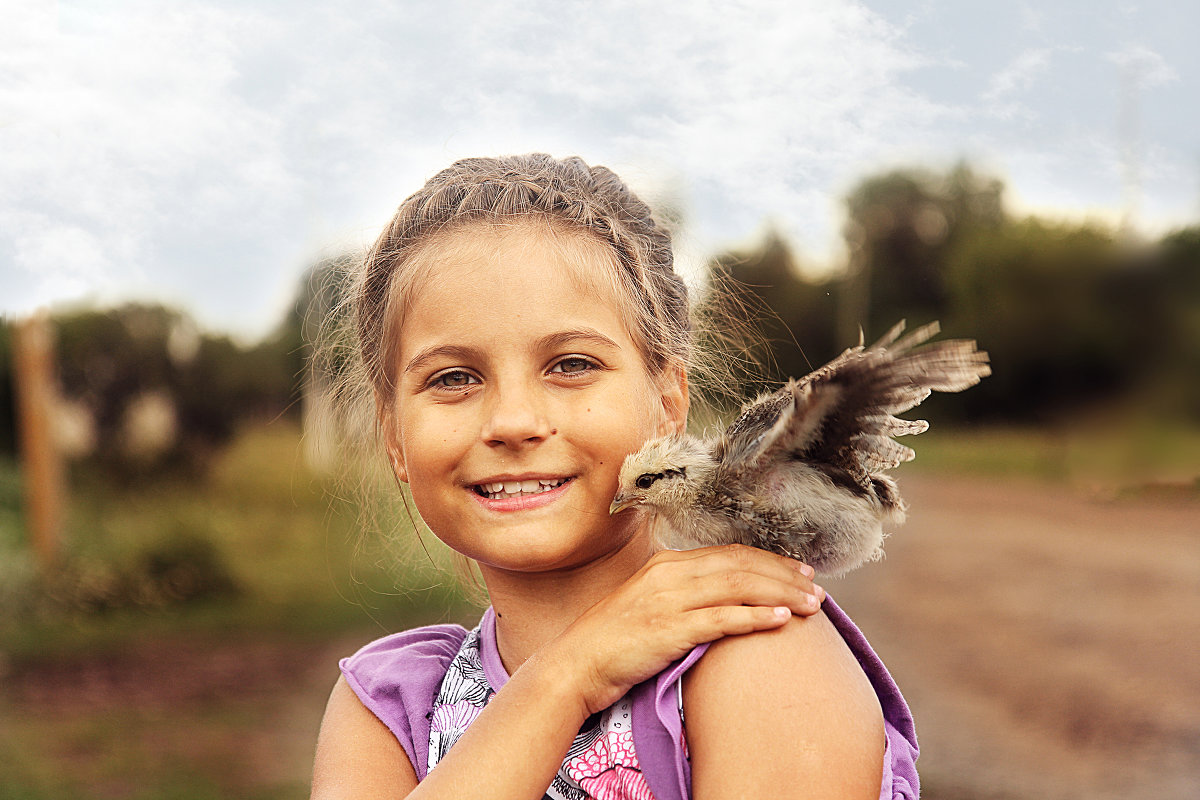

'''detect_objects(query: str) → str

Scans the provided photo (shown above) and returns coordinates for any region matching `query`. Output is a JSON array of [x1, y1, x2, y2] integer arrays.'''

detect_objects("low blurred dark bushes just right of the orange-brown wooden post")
[[56, 305, 295, 480]]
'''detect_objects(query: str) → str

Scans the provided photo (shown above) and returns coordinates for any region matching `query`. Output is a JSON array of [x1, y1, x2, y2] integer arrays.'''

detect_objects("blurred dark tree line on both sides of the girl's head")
[[0, 159, 1200, 480]]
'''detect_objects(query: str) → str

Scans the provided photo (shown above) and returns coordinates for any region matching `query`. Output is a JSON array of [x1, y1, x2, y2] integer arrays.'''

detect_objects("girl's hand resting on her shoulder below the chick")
[[542, 545, 824, 715]]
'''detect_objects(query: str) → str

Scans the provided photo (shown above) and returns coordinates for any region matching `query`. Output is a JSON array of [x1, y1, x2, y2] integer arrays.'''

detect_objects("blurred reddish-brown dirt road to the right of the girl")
[[826, 475, 1200, 800]]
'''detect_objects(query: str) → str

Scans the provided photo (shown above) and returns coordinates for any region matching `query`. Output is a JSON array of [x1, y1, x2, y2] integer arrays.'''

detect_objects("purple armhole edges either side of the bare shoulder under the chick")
[[634, 597, 920, 800]]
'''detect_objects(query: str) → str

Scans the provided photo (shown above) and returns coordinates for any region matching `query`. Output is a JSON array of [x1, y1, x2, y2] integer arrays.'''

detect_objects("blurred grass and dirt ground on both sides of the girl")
[[0, 423, 1200, 800]]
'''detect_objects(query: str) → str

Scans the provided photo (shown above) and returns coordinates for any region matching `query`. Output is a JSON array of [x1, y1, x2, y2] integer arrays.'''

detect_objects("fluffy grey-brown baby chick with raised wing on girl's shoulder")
[[610, 321, 991, 576]]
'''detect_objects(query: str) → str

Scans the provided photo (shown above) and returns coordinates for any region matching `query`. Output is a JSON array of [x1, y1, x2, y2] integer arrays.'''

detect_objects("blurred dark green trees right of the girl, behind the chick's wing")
[[714, 164, 1200, 423]]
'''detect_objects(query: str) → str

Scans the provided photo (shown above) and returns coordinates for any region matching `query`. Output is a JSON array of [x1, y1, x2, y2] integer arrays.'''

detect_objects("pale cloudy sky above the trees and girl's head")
[[0, 0, 1200, 341]]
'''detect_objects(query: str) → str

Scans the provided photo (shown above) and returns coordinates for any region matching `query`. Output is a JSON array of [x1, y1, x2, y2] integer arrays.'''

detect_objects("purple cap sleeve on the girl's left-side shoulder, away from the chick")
[[340, 625, 467, 781]]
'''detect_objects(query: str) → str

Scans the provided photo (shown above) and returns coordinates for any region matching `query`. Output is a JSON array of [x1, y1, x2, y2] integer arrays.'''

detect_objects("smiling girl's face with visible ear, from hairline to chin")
[[384, 222, 688, 572]]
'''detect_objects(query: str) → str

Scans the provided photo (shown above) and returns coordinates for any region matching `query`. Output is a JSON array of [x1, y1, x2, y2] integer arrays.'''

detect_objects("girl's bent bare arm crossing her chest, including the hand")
[[313, 546, 823, 800]]
